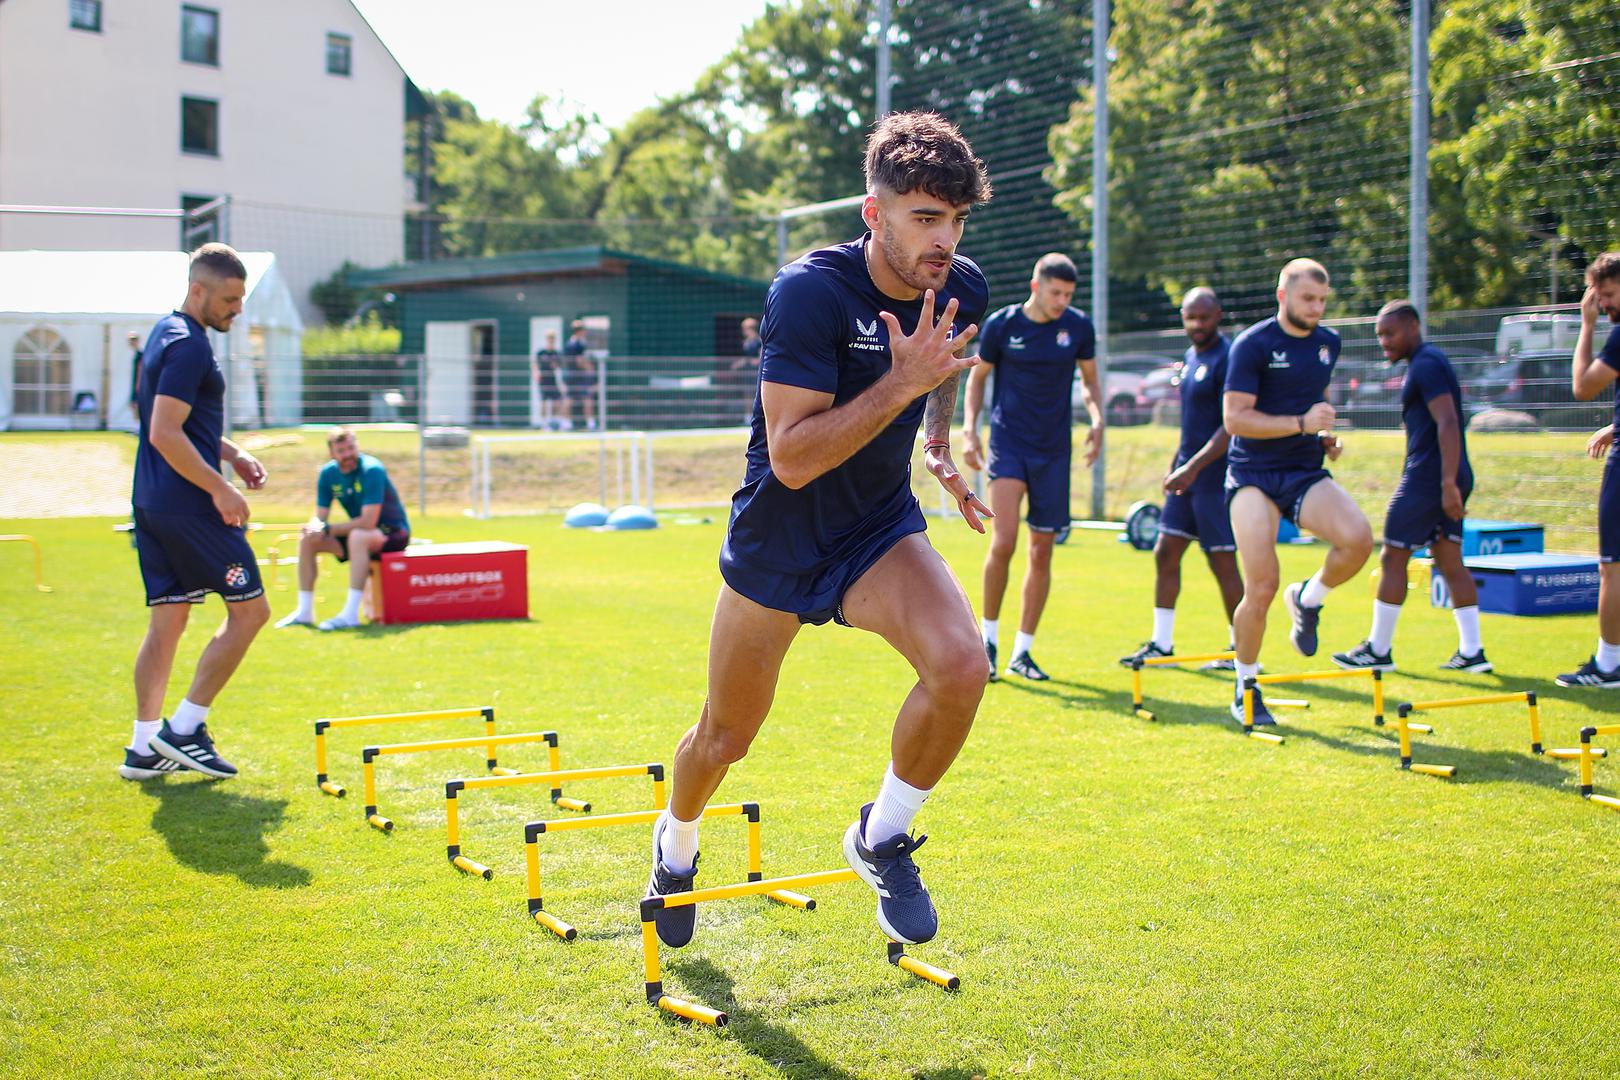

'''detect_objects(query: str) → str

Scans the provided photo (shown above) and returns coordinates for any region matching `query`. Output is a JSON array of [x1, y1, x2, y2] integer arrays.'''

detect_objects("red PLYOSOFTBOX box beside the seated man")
[[376, 541, 528, 623]]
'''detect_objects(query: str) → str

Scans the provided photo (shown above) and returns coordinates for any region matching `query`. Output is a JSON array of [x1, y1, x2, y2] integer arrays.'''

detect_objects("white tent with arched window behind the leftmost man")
[[0, 251, 303, 431]]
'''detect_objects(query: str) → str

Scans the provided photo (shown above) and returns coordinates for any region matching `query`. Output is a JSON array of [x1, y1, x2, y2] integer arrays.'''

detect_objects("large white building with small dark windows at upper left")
[[0, 0, 421, 321]]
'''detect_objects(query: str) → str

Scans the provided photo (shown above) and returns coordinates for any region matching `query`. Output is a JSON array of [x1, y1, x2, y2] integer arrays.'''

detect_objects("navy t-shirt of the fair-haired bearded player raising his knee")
[[1226, 316, 1338, 470]]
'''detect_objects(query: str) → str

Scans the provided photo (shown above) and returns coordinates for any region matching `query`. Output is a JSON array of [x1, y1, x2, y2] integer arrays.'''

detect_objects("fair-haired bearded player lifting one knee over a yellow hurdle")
[[1223, 259, 1372, 724]]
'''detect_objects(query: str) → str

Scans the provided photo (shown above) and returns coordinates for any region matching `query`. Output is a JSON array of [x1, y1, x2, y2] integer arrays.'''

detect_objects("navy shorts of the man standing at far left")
[[134, 507, 264, 607]]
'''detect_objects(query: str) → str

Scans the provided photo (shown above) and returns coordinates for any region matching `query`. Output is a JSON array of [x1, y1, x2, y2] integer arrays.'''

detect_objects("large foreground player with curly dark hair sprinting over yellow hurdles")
[[648, 112, 990, 946]]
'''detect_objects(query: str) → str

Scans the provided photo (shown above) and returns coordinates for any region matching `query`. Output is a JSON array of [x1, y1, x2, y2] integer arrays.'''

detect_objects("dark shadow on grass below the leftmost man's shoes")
[[141, 779, 309, 889]]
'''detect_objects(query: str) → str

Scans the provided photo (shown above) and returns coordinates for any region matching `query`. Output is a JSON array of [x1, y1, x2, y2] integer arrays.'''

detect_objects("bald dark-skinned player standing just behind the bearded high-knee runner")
[[1119, 287, 1243, 670]]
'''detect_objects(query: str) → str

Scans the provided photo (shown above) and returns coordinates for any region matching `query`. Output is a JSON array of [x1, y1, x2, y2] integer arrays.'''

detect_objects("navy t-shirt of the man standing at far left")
[[131, 311, 225, 513]]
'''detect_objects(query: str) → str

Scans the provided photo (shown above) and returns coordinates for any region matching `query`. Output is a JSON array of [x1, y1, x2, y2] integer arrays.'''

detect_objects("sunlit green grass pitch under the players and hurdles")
[[0, 501, 1620, 1080]]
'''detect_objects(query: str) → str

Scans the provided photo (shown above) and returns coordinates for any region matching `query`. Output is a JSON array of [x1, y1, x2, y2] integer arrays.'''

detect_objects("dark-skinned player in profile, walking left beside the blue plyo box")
[[1333, 300, 1492, 672]]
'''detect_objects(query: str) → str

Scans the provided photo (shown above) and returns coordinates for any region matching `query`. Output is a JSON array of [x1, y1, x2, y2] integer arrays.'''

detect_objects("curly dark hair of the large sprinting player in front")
[[865, 110, 990, 206]]
